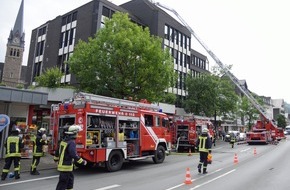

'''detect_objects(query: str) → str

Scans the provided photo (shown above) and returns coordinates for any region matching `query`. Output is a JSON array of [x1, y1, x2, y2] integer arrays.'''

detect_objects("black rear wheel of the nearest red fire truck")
[[106, 151, 124, 172]]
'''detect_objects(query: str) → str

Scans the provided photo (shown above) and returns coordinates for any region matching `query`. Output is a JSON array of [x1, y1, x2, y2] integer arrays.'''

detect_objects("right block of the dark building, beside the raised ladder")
[[120, 0, 209, 106]]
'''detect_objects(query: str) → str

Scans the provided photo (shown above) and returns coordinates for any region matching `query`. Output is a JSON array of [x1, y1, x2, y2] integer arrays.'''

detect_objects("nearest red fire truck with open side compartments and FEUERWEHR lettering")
[[50, 93, 171, 171]]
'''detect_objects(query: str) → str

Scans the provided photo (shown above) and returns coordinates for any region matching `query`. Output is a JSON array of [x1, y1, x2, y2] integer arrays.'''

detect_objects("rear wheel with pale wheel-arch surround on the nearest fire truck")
[[106, 149, 127, 172]]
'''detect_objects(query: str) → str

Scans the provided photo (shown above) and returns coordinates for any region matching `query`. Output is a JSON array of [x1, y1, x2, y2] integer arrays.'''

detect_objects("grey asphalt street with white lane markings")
[[0, 139, 290, 190]]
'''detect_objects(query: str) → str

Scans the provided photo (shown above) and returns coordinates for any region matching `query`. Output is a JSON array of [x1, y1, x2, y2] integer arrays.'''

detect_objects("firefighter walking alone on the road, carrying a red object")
[[196, 128, 212, 174]]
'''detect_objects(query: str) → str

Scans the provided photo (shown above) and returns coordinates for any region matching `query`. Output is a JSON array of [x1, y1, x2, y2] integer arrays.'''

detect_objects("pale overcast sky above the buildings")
[[0, 0, 290, 103]]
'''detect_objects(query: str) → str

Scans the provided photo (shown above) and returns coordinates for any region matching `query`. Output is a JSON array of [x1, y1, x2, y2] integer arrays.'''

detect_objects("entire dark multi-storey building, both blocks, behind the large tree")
[[26, 0, 208, 107]]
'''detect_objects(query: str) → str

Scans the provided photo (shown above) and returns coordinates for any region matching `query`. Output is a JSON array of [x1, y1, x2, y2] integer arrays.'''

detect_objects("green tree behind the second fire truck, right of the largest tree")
[[184, 74, 238, 117]]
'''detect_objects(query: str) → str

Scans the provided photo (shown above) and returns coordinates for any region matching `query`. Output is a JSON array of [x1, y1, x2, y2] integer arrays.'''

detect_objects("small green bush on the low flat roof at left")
[[35, 67, 62, 88]]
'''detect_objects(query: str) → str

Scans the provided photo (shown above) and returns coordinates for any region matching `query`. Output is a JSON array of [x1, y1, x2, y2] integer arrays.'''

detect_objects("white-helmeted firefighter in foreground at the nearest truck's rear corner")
[[54, 125, 87, 190]]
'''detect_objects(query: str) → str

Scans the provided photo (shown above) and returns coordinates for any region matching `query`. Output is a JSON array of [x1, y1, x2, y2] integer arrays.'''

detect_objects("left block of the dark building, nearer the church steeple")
[[26, 0, 140, 85]]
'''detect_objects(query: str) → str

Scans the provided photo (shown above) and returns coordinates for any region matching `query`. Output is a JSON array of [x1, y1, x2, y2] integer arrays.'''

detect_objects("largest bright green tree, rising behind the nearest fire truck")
[[69, 12, 176, 101]]
